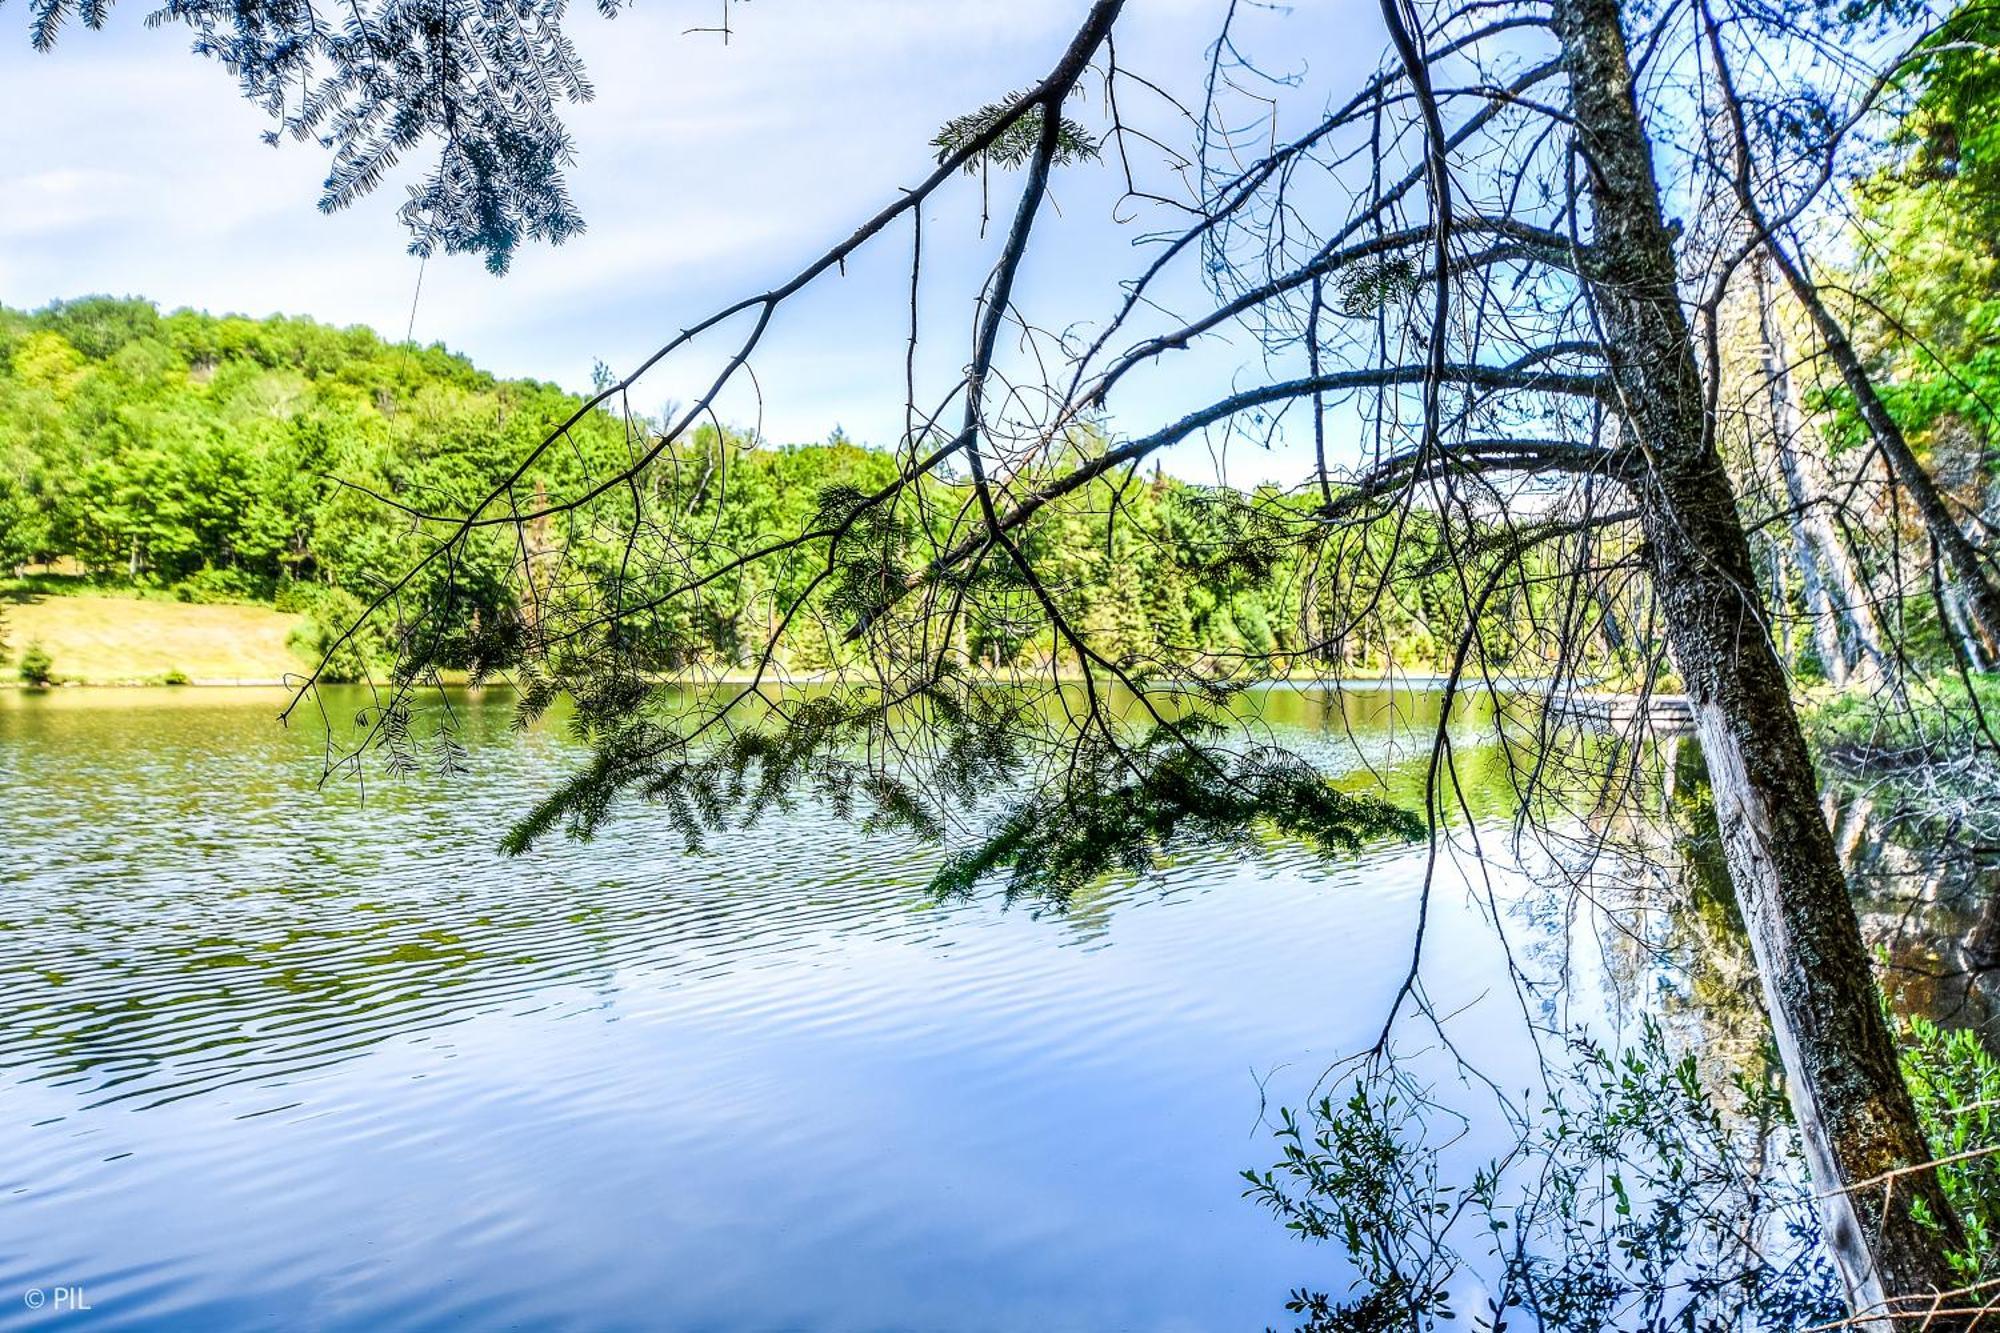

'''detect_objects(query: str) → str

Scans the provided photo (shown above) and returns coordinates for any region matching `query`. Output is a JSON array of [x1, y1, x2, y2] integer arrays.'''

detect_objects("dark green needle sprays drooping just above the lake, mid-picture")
[[504, 673, 1424, 892]]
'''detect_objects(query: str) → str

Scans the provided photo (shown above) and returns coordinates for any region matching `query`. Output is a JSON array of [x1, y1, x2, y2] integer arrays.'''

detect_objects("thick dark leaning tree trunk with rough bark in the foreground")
[[1554, 0, 1962, 1327]]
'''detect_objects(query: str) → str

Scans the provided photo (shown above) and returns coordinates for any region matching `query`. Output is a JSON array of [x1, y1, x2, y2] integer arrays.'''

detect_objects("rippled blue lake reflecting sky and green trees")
[[0, 691, 1624, 1331]]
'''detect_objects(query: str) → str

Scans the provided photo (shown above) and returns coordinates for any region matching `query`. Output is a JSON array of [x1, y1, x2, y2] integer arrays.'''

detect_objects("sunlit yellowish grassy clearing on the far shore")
[[0, 590, 302, 685]]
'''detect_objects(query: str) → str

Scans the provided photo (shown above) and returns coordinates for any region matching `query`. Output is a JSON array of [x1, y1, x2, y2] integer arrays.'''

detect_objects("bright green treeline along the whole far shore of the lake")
[[0, 296, 1620, 671]]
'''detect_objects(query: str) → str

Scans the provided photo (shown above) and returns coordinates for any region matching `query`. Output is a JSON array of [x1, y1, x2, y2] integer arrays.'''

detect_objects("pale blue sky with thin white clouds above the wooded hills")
[[0, 0, 1380, 482]]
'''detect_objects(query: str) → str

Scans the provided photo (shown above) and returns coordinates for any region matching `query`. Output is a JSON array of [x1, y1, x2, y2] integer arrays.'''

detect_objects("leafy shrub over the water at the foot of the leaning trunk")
[[1244, 1021, 1844, 1333]]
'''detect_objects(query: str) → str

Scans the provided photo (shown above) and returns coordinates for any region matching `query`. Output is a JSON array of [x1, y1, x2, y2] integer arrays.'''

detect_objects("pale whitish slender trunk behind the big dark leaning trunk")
[[1754, 254, 1894, 685]]
